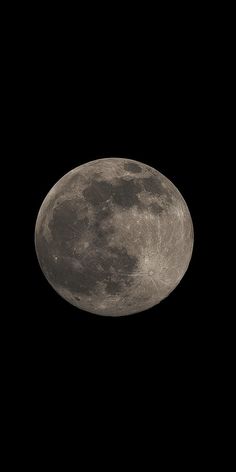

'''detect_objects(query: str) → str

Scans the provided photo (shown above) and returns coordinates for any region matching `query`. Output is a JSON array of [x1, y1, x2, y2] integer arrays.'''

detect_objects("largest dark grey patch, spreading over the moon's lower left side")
[[36, 189, 138, 295]]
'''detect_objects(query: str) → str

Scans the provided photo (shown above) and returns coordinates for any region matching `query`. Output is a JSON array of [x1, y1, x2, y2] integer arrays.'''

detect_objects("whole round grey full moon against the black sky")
[[35, 157, 194, 316]]
